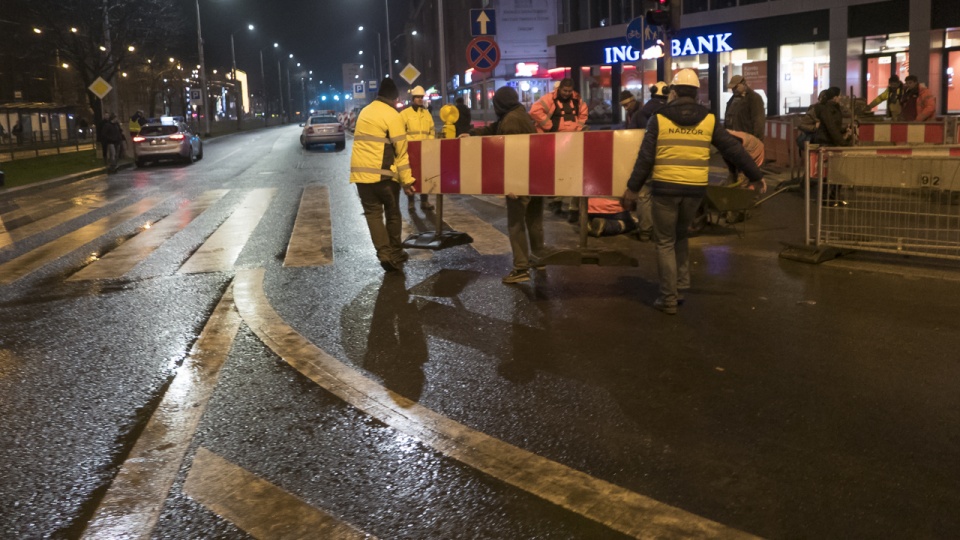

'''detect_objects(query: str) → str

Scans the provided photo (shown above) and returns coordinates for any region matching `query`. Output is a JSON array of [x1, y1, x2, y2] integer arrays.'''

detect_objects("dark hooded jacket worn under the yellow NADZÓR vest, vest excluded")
[[627, 98, 763, 197]]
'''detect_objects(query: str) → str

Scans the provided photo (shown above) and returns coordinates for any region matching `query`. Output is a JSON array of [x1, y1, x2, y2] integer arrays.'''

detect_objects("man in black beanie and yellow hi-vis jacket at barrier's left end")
[[350, 78, 415, 271]]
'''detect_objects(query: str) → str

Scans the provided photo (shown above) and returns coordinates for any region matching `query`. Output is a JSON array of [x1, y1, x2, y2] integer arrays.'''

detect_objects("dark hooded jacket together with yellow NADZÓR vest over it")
[[627, 98, 763, 197]]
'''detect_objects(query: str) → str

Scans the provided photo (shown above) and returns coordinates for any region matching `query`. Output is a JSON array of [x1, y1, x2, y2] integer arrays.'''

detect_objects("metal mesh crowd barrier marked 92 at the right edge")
[[804, 145, 960, 260]]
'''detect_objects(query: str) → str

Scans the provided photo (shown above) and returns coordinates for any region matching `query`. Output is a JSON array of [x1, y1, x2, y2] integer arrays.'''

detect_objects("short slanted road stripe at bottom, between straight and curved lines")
[[183, 447, 376, 540]]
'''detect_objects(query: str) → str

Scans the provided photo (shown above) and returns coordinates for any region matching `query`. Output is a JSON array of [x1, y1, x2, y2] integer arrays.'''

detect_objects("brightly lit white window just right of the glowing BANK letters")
[[777, 41, 830, 114]]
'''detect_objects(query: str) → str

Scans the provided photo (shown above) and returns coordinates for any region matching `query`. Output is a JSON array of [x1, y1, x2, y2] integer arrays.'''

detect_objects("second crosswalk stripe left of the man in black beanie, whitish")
[[177, 188, 277, 274]]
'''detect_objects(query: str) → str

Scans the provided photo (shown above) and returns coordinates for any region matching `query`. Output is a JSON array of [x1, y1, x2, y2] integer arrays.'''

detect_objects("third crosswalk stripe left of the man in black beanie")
[[67, 189, 227, 281]]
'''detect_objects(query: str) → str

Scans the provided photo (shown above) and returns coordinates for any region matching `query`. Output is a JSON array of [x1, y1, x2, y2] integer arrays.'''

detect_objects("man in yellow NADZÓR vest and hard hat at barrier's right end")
[[623, 69, 767, 315]]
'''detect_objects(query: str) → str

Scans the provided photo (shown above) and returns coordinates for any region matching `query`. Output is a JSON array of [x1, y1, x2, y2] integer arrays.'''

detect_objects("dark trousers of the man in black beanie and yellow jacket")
[[357, 180, 403, 262]]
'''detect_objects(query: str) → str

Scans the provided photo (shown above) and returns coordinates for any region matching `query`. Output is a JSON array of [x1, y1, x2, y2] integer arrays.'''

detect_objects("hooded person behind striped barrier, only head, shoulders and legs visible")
[[470, 86, 545, 283]]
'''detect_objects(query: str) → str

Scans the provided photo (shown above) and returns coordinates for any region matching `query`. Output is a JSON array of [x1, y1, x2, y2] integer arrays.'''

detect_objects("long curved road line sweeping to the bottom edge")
[[234, 268, 753, 538]]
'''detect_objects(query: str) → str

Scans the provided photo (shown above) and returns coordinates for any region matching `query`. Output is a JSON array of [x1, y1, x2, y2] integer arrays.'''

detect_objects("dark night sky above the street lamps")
[[195, 0, 413, 91]]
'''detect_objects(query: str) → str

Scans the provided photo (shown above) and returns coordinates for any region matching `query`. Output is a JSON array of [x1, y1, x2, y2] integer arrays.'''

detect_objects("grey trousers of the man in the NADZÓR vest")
[[653, 195, 703, 306]]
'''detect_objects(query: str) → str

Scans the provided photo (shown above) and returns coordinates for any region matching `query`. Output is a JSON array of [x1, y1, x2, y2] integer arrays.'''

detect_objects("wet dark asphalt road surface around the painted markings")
[[0, 126, 960, 538]]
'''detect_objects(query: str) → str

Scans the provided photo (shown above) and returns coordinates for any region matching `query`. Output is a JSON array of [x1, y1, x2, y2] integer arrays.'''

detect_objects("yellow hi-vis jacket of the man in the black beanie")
[[350, 99, 414, 186]]
